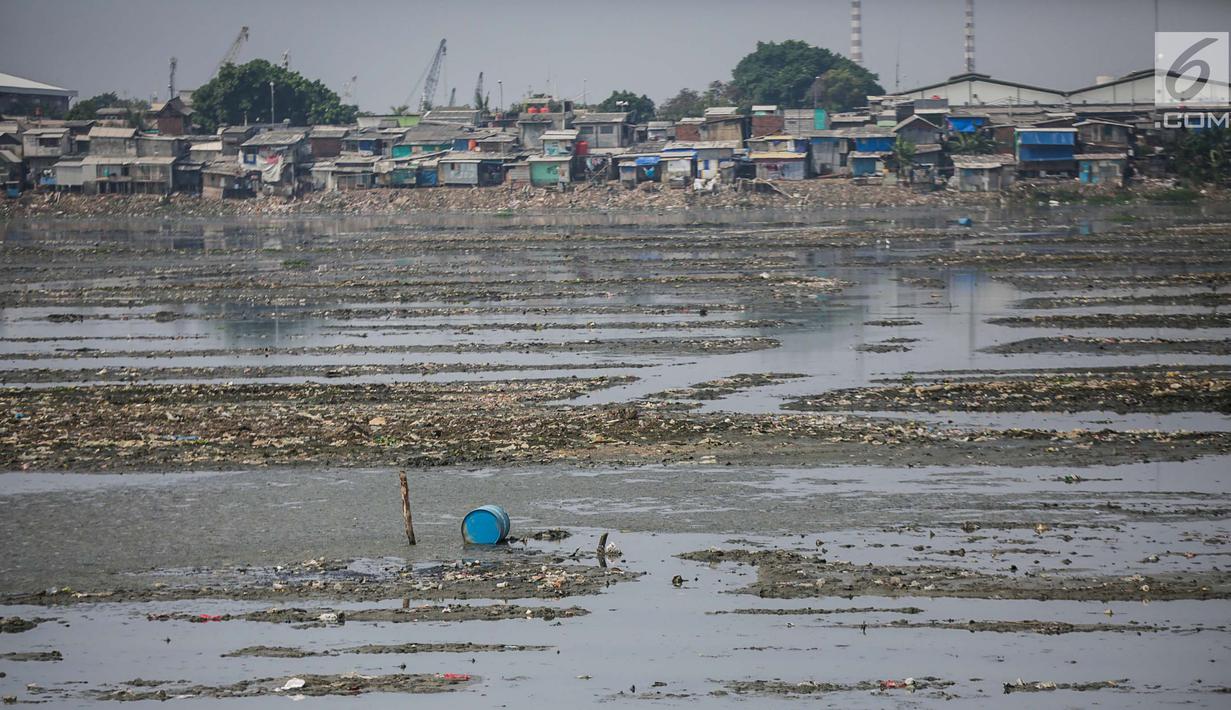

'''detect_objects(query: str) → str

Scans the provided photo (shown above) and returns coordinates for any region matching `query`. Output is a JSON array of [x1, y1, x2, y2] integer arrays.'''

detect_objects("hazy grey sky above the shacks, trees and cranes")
[[7, 0, 1231, 112]]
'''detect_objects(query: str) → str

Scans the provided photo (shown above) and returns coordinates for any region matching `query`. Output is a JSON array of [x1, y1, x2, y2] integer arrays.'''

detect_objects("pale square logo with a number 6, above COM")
[[1155, 32, 1231, 108]]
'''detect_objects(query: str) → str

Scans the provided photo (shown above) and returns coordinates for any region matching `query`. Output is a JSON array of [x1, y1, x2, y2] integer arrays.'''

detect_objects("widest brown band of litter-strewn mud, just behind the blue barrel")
[[9, 378, 1231, 470]]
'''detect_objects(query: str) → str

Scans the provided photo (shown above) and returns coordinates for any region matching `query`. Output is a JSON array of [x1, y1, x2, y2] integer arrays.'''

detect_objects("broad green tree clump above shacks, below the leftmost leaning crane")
[[192, 59, 358, 132]]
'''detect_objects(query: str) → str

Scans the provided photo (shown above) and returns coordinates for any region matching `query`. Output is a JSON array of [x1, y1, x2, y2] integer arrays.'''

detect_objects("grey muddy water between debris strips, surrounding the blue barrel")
[[0, 207, 1231, 708]]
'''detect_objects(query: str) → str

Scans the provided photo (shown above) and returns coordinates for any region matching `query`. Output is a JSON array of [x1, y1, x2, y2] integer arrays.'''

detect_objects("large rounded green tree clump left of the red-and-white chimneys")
[[730, 39, 885, 111]]
